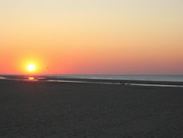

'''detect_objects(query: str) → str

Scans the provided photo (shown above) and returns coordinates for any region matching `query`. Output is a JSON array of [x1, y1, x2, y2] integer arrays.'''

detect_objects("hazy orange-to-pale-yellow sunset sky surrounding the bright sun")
[[0, 0, 183, 74]]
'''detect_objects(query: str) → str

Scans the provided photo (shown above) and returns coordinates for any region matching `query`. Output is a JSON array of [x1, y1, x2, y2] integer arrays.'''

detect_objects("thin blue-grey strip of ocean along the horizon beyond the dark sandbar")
[[52, 75, 183, 82]]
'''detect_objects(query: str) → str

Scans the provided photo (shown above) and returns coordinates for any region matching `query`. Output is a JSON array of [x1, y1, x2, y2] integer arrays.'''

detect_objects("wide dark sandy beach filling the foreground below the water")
[[0, 80, 183, 138]]
